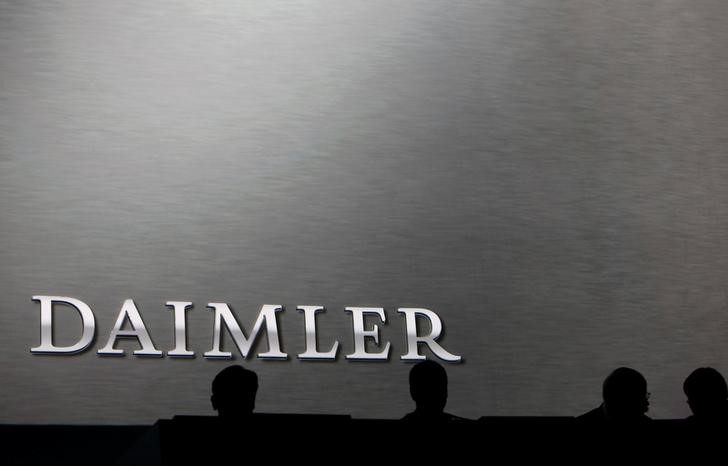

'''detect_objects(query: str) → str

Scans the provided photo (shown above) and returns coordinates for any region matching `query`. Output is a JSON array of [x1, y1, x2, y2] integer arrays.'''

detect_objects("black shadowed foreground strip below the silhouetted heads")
[[0, 414, 728, 466]]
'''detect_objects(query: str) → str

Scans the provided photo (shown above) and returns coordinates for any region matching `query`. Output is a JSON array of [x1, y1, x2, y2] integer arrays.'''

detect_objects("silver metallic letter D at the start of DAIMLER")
[[30, 296, 96, 354]]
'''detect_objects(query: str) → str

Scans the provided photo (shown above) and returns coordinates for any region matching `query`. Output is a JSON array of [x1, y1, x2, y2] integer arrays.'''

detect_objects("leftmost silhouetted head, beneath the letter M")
[[210, 366, 258, 418]]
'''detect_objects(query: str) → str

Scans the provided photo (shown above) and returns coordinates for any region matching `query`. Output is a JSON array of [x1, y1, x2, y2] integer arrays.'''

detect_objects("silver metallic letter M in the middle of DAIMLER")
[[204, 303, 288, 359]]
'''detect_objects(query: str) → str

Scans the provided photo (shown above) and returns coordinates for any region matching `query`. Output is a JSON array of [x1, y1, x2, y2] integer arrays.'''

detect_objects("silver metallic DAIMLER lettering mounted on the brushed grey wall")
[[30, 296, 462, 362]]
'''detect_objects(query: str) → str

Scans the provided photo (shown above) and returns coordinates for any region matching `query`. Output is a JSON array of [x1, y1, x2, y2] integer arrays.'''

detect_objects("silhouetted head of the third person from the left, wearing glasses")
[[602, 367, 650, 420]]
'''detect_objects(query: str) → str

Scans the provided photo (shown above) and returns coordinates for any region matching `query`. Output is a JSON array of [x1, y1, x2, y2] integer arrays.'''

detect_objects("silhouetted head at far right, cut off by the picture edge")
[[683, 367, 728, 418]]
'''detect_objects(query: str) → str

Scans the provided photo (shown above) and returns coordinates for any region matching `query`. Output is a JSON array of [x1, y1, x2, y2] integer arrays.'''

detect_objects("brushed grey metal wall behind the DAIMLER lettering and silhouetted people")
[[0, 0, 728, 423]]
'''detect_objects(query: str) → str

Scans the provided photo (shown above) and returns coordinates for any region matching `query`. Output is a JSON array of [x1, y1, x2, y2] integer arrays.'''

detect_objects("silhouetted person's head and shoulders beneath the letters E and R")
[[402, 361, 462, 422]]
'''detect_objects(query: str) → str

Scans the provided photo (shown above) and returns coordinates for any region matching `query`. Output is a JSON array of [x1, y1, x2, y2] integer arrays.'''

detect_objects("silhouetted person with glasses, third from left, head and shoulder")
[[577, 367, 650, 425]]
